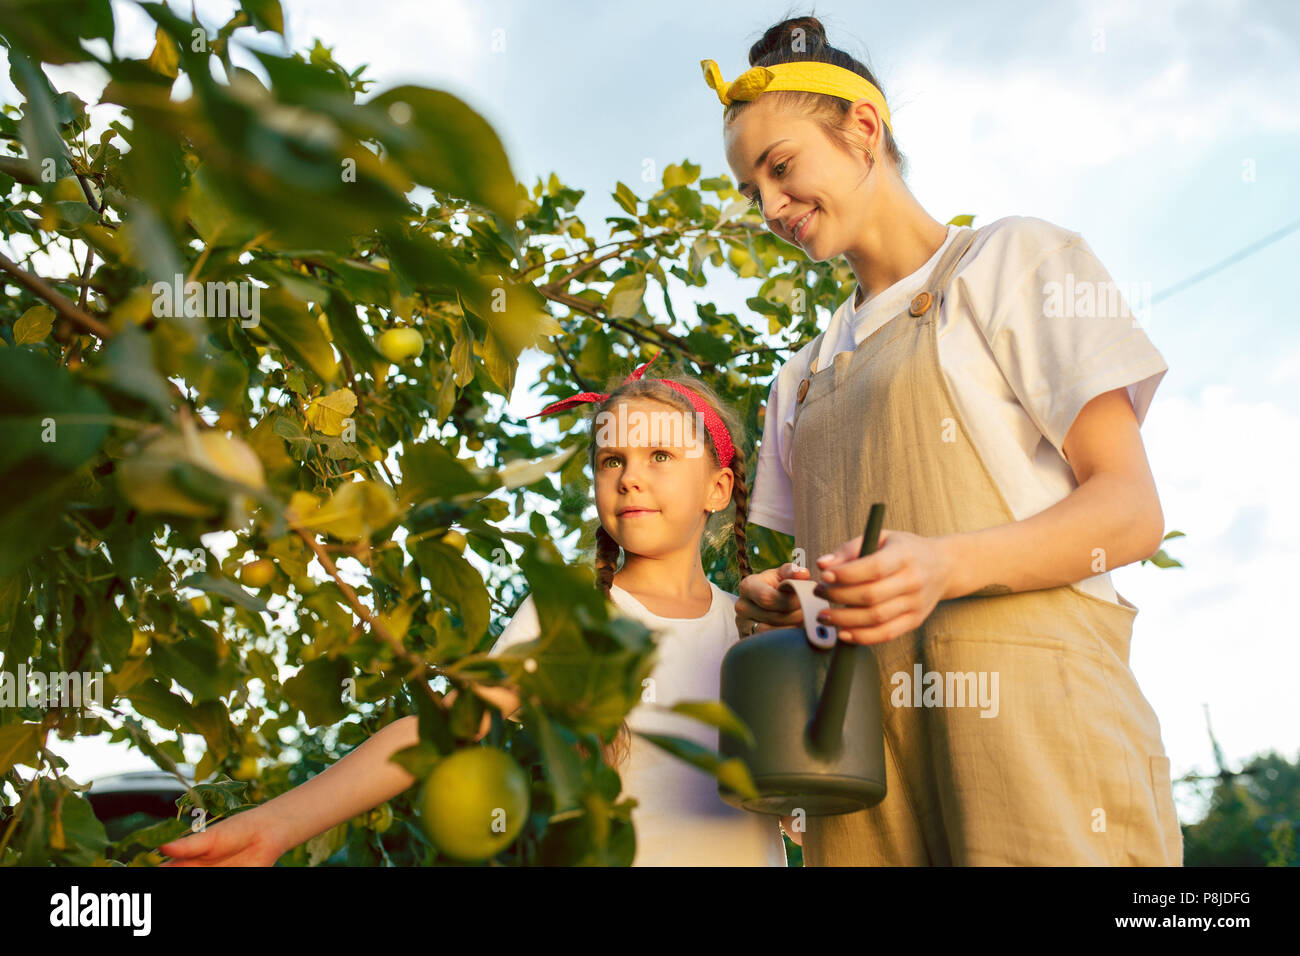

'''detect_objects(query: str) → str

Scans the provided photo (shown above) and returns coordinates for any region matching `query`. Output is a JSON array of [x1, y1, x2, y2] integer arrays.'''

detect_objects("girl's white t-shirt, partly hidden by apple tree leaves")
[[490, 581, 787, 866]]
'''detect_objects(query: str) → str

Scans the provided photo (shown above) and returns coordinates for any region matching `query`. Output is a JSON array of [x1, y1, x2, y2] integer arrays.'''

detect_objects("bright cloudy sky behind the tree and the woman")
[[10, 0, 1300, 821]]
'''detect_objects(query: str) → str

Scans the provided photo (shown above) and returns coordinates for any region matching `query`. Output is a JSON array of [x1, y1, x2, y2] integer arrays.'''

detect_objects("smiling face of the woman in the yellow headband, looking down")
[[723, 96, 880, 261]]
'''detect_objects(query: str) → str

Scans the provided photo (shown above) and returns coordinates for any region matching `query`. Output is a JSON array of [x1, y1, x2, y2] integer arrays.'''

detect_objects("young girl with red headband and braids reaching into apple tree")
[[159, 356, 785, 866]]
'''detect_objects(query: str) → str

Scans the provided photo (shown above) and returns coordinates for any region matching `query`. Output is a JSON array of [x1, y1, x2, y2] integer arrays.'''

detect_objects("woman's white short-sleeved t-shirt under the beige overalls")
[[749, 216, 1169, 604]]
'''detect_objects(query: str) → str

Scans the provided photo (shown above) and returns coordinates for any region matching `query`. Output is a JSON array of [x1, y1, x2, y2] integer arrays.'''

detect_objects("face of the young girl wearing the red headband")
[[593, 398, 733, 557]]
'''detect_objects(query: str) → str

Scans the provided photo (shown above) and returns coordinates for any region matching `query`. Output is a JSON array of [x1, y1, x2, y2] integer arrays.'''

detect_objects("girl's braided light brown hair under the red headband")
[[577, 358, 750, 767]]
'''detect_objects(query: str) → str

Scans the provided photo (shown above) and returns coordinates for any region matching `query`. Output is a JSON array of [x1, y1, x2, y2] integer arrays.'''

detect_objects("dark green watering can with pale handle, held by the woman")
[[718, 503, 885, 817]]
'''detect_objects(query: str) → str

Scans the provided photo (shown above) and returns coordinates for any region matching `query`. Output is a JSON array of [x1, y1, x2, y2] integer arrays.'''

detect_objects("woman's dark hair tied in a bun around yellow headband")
[[723, 16, 907, 177]]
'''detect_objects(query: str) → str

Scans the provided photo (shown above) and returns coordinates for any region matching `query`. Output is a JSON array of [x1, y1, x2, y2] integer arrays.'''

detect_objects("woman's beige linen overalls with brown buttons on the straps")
[[792, 229, 1183, 866]]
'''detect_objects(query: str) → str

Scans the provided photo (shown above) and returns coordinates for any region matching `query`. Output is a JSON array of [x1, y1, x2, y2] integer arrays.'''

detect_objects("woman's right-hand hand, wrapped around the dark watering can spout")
[[813, 529, 953, 644]]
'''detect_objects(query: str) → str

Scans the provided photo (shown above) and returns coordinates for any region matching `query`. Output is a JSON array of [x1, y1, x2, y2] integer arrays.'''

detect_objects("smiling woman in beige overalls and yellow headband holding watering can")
[[717, 17, 1182, 865]]
